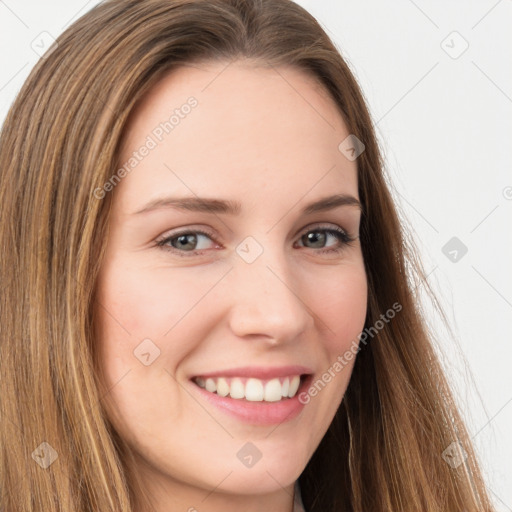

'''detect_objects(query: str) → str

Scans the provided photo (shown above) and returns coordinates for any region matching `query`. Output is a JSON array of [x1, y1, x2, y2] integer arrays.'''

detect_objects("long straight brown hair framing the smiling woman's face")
[[0, 0, 493, 512]]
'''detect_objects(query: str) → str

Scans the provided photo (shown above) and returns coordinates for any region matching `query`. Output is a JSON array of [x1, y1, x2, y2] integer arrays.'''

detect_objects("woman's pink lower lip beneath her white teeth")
[[192, 375, 311, 425]]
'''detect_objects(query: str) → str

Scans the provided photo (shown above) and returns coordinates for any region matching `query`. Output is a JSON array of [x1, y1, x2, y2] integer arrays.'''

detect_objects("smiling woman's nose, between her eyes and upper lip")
[[228, 244, 314, 345]]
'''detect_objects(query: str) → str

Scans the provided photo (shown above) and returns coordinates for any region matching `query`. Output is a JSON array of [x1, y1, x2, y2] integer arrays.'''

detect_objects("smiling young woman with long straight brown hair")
[[0, 0, 492, 512]]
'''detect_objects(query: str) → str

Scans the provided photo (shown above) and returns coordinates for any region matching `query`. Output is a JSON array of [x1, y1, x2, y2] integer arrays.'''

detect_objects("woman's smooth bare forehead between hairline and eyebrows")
[[115, 61, 357, 216]]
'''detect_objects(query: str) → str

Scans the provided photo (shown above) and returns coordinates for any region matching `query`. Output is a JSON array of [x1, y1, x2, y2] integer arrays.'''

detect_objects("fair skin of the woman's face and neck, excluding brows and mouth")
[[96, 61, 367, 512]]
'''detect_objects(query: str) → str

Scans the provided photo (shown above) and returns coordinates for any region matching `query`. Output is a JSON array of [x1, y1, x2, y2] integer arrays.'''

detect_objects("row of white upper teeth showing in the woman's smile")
[[195, 375, 300, 402]]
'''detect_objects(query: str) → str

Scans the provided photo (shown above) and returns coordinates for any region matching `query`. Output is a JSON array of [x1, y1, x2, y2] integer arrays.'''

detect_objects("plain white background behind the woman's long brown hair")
[[0, 0, 512, 512]]
